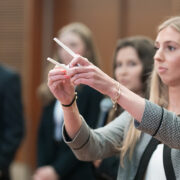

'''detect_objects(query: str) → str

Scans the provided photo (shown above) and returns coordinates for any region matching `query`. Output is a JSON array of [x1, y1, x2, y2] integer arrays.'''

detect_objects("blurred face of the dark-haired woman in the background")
[[115, 46, 143, 94]]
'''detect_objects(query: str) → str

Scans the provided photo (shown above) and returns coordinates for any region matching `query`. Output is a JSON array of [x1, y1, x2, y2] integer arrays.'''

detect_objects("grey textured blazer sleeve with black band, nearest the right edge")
[[135, 100, 180, 149]]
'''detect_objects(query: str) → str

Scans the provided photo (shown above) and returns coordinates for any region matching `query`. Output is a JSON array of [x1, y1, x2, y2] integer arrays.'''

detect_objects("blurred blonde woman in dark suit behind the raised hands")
[[33, 23, 103, 180]]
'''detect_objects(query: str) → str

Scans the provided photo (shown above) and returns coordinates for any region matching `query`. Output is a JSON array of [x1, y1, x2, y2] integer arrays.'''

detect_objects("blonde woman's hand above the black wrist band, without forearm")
[[48, 67, 75, 104]]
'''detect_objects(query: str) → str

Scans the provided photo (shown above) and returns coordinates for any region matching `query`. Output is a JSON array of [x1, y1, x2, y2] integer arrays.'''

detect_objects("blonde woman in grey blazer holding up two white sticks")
[[48, 16, 180, 180]]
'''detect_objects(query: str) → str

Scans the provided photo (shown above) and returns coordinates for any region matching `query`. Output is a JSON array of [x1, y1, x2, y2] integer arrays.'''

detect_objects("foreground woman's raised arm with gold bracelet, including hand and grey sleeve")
[[69, 57, 180, 149]]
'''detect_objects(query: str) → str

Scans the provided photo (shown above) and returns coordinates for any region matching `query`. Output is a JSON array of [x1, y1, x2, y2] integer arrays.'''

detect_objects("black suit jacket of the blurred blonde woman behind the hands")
[[38, 85, 103, 180]]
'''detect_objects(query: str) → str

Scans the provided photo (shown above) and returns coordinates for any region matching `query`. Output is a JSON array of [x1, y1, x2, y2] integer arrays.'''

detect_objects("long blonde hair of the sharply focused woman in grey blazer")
[[120, 16, 180, 167]]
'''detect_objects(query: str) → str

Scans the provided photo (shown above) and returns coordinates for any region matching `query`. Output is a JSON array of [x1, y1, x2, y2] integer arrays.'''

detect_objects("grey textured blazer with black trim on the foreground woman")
[[63, 101, 180, 180]]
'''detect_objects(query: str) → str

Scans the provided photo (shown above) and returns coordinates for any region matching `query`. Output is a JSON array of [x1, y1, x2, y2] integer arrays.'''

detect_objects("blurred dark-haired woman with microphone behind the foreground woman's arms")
[[94, 36, 155, 180]]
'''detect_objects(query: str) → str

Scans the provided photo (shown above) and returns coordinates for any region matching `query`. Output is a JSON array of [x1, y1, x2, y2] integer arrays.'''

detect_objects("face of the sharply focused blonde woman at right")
[[154, 26, 180, 86]]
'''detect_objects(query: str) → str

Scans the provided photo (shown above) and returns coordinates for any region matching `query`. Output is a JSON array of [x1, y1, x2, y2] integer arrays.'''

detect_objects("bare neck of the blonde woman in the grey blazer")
[[168, 86, 180, 114]]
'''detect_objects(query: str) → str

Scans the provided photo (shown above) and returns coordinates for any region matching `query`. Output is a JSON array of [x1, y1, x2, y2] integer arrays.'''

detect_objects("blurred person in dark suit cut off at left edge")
[[0, 64, 24, 180]]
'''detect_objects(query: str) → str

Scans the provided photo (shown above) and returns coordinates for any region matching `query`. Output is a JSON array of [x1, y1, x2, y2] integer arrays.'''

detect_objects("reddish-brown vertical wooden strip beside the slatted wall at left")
[[24, 0, 43, 168]]
